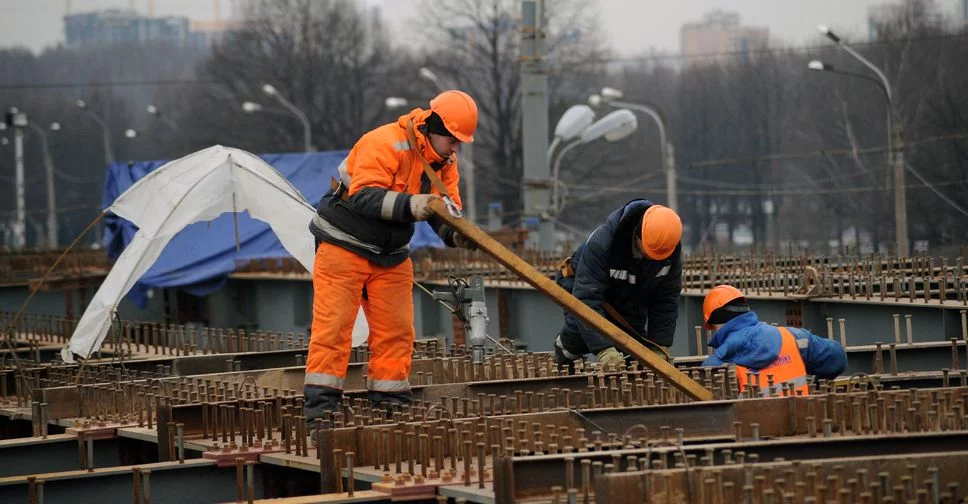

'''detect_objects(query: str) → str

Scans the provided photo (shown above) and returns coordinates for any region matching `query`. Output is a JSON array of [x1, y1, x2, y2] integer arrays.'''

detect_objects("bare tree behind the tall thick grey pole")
[[421, 0, 605, 220]]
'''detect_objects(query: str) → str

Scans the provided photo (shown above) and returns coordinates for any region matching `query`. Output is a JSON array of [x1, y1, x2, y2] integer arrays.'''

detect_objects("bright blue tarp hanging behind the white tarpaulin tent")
[[102, 151, 444, 308]]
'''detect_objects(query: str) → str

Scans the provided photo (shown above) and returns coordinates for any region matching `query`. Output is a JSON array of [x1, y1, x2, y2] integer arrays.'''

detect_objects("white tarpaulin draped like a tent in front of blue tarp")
[[61, 145, 369, 362]]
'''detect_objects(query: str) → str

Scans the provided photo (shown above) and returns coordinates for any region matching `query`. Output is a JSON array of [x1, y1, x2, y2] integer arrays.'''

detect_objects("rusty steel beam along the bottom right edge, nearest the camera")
[[594, 451, 968, 504]]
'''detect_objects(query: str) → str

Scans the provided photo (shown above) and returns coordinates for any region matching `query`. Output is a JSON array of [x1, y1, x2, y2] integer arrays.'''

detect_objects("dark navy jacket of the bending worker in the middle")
[[557, 199, 682, 354]]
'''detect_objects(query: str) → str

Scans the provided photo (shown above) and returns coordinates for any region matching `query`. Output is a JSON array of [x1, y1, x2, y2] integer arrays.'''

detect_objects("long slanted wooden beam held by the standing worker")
[[430, 199, 713, 401]]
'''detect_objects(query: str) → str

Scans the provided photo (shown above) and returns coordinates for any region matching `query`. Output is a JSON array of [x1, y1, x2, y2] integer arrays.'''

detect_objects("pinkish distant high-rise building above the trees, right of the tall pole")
[[679, 10, 770, 65]]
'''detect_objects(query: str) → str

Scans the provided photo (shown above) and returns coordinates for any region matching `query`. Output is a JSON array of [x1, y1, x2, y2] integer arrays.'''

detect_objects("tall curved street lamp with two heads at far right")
[[807, 25, 910, 257]]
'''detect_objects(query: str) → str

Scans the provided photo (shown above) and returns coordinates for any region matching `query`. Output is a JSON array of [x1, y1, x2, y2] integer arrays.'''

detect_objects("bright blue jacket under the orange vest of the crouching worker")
[[702, 312, 847, 379]]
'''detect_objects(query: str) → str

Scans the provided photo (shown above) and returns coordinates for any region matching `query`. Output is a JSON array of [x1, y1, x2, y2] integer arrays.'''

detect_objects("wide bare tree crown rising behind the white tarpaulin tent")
[[183, 0, 418, 155]]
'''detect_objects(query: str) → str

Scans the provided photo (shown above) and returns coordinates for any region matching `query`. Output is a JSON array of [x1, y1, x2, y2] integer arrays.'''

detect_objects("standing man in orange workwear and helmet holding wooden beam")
[[303, 90, 477, 423]]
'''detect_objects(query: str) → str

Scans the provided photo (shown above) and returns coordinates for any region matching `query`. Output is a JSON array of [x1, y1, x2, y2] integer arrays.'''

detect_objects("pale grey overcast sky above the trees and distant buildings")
[[0, 0, 961, 55]]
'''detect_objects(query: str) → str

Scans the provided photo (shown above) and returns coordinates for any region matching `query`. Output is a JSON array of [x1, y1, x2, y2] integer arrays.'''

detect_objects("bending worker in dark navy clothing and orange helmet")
[[555, 199, 682, 368]]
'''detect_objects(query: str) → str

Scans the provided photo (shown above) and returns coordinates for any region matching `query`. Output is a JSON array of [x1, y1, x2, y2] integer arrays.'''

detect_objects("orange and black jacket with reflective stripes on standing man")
[[309, 109, 463, 266]]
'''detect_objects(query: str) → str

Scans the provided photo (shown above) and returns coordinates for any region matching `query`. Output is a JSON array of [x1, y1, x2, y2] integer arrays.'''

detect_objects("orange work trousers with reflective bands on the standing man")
[[305, 242, 415, 393]]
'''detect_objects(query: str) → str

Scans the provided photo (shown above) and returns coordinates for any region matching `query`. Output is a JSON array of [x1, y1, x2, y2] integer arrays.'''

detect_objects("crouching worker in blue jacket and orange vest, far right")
[[702, 285, 847, 397]]
